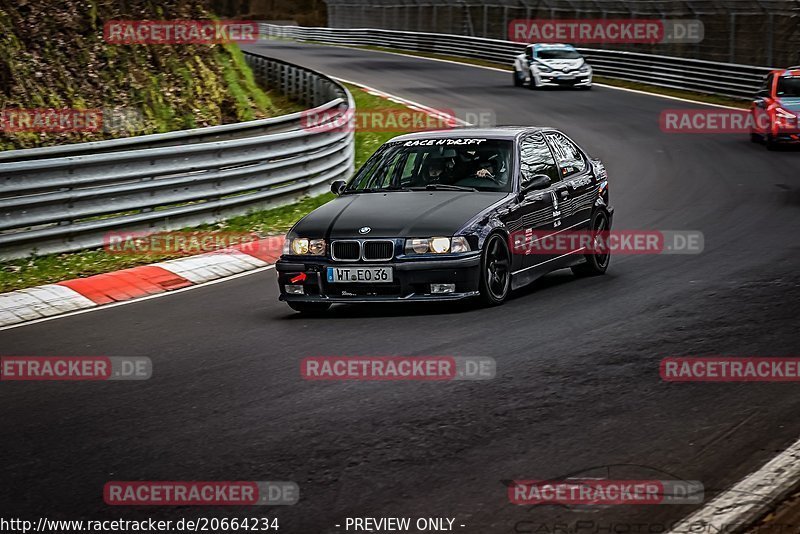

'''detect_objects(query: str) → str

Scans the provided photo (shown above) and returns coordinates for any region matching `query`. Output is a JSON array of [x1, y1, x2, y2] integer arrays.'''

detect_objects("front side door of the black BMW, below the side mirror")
[[506, 132, 559, 270]]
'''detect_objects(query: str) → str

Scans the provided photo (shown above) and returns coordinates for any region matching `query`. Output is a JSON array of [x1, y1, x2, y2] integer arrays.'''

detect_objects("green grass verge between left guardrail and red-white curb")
[[0, 85, 416, 292]]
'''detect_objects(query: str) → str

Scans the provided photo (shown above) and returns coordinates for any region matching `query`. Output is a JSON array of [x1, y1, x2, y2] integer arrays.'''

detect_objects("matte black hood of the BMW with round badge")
[[293, 191, 509, 239]]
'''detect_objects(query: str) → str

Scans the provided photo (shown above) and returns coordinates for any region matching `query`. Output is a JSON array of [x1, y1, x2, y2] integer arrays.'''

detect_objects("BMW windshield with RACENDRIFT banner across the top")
[[345, 138, 512, 192]]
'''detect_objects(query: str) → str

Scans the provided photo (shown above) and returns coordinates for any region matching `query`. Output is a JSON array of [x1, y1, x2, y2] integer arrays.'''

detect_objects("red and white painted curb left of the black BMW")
[[0, 237, 283, 327]]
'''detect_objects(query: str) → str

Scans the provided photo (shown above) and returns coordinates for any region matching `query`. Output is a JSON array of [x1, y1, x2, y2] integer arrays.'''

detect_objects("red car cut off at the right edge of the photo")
[[750, 66, 800, 150]]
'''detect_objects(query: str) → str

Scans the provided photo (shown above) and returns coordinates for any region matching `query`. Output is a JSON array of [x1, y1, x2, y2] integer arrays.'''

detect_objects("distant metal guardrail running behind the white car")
[[262, 24, 770, 99]]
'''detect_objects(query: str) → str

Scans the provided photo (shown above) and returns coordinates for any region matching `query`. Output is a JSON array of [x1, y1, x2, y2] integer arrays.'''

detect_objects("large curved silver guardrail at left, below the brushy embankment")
[[0, 53, 355, 260]]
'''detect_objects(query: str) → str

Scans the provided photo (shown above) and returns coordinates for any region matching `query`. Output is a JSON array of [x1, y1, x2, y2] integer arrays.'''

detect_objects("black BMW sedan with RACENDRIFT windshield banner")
[[276, 127, 613, 313]]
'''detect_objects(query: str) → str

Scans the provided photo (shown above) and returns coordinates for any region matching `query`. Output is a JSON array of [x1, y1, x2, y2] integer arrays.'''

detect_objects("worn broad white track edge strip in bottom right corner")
[[670, 440, 800, 534]]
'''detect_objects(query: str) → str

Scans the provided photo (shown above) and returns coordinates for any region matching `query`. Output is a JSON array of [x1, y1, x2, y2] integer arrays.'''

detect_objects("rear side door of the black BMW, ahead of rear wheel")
[[545, 131, 597, 231]]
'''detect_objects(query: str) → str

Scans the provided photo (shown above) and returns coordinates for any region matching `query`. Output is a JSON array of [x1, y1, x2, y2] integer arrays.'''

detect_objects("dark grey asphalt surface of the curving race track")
[[0, 39, 800, 534]]
